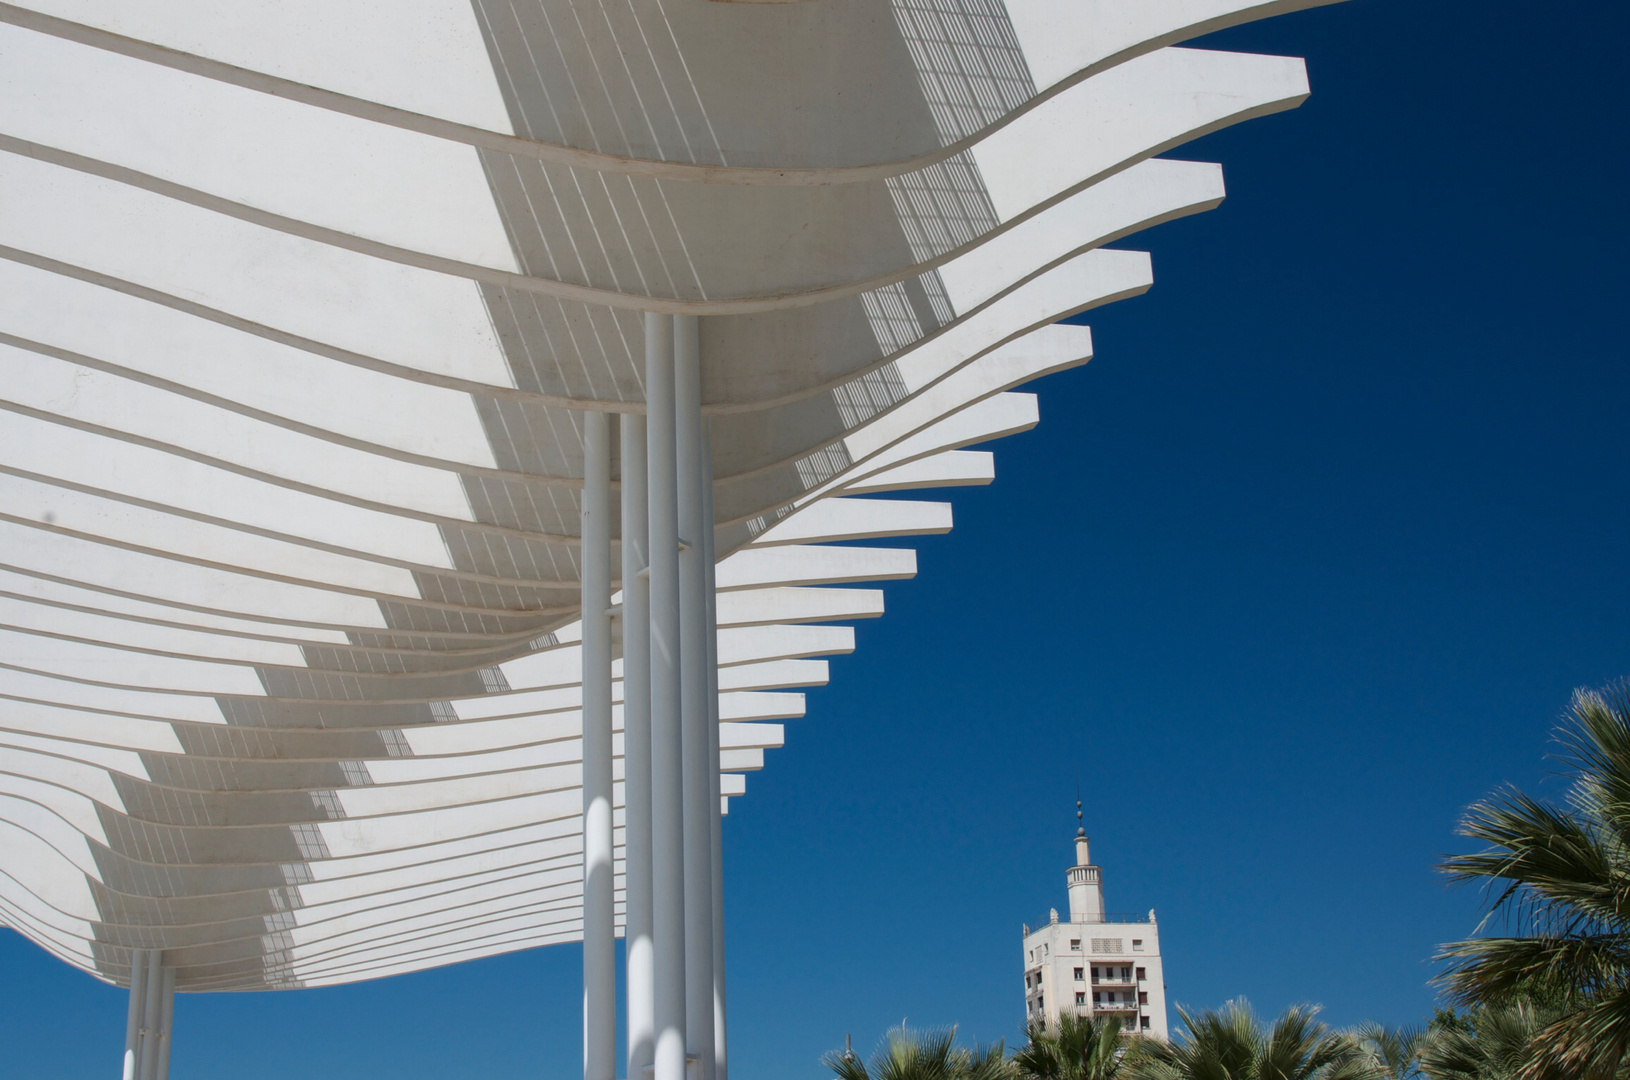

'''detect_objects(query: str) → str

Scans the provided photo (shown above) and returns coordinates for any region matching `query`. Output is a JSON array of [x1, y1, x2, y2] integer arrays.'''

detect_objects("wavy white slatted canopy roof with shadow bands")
[[0, 0, 1324, 1016]]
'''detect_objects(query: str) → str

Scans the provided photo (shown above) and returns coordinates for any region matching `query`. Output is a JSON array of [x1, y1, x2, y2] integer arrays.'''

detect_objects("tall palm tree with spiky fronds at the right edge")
[[1439, 683, 1630, 1080]]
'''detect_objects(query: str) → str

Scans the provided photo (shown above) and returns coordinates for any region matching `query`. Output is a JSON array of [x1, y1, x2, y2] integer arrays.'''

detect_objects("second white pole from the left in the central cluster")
[[618, 412, 657, 1080]]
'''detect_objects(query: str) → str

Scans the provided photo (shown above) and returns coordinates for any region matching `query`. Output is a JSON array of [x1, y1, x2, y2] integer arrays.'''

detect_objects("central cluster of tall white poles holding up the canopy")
[[582, 314, 725, 1080]]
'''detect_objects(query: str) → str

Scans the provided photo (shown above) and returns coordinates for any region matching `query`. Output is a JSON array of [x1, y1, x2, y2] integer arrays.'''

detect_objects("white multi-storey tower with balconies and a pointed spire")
[[1024, 801, 1167, 1039]]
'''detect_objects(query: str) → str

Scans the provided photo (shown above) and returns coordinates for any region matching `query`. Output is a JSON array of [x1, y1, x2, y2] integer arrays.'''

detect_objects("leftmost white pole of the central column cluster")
[[580, 412, 616, 1080]]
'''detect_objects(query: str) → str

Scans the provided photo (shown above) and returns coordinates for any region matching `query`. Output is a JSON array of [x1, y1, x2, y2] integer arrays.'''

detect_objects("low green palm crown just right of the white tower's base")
[[1123, 999, 1384, 1080]]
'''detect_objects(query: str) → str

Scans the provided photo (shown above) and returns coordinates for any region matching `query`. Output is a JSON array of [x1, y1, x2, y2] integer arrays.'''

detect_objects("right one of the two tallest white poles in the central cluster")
[[673, 314, 719, 1080]]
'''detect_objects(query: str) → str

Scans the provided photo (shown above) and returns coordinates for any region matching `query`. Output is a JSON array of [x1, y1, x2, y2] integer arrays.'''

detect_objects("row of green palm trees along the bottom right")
[[822, 683, 1630, 1080]]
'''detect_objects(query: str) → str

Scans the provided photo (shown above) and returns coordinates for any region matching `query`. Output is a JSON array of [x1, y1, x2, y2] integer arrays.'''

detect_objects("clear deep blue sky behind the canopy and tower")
[[0, 0, 1630, 1080]]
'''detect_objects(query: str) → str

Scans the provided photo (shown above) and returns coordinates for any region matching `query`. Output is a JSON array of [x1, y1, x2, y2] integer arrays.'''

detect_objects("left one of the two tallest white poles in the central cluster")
[[631, 314, 685, 1080]]
